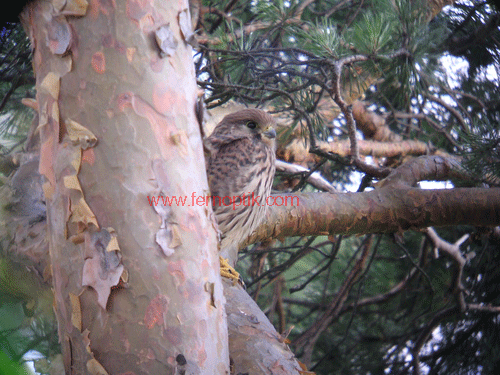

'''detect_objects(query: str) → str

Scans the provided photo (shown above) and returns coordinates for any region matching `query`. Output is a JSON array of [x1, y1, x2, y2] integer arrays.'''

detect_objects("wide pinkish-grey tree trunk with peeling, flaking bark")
[[22, 0, 229, 374]]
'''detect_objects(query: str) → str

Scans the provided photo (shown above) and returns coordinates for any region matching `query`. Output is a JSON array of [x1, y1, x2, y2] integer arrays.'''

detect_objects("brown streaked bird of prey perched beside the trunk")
[[206, 109, 276, 278]]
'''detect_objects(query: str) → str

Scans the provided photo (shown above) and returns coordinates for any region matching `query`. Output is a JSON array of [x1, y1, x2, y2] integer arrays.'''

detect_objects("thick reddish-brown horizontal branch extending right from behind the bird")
[[242, 186, 500, 245]]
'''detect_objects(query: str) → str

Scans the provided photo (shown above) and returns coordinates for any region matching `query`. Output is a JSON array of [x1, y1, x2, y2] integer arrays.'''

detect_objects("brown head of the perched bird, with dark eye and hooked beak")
[[210, 108, 276, 149]]
